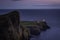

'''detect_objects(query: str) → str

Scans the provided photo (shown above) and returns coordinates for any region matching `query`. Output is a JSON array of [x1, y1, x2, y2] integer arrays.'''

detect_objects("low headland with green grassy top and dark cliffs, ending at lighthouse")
[[21, 21, 50, 36]]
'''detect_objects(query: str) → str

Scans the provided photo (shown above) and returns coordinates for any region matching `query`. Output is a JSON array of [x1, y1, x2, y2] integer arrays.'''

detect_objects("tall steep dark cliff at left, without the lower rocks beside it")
[[0, 11, 19, 40]]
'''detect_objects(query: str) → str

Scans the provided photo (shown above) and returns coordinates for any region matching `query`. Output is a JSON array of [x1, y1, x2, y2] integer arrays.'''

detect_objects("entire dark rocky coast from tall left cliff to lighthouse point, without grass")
[[0, 11, 49, 40]]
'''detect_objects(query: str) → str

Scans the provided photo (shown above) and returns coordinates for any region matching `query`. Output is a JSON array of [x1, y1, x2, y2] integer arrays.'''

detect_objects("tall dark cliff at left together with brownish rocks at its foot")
[[0, 11, 30, 40]]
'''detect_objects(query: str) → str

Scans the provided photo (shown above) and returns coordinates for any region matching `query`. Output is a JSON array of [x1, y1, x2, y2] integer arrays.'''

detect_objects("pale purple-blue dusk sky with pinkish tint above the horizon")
[[0, 0, 60, 9]]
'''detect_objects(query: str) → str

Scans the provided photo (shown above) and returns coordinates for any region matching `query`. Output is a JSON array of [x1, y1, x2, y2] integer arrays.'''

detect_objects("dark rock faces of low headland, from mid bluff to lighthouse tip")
[[27, 21, 50, 36]]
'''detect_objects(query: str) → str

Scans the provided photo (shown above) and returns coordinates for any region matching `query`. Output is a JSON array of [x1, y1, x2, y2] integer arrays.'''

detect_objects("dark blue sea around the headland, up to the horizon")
[[0, 9, 60, 40]]
